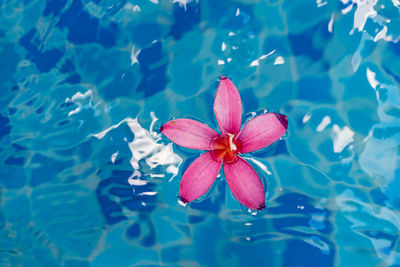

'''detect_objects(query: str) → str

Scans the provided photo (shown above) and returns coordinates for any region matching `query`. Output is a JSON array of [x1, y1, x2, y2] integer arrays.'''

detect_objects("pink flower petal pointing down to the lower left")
[[179, 151, 222, 203]]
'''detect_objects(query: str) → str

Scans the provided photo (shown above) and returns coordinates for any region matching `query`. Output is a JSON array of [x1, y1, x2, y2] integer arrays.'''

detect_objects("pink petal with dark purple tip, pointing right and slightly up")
[[236, 113, 288, 153]]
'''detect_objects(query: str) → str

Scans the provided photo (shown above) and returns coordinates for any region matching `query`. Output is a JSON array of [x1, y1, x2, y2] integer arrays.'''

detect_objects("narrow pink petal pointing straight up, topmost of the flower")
[[214, 76, 242, 135]]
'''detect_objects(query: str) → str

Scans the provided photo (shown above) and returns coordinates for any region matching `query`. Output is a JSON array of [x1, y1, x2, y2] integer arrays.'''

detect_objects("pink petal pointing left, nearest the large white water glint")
[[161, 119, 219, 150]]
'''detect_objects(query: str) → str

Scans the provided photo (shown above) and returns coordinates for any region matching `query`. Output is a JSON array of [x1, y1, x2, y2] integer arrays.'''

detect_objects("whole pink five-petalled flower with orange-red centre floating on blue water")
[[161, 76, 288, 210]]
